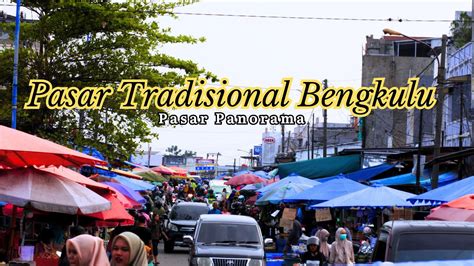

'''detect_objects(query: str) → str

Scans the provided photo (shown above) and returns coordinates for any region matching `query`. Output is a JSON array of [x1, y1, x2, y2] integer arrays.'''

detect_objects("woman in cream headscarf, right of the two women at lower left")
[[110, 232, 148, 266]]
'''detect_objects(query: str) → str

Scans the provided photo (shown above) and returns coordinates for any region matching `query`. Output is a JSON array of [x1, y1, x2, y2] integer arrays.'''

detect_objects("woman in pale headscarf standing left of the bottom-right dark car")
[[329, 228, 355, 265]]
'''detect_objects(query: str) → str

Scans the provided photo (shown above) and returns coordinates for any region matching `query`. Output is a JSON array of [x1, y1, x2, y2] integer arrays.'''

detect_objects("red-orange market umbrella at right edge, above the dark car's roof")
[[426, 194, 474, 222]]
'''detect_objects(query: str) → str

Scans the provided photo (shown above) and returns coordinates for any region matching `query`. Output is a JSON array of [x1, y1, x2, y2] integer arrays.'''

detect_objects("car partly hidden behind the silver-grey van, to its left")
[[163, 202, 209, 253]]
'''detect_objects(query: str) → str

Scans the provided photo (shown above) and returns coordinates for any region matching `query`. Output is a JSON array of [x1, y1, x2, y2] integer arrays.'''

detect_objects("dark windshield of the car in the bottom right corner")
[[394, 232, 474, 262]]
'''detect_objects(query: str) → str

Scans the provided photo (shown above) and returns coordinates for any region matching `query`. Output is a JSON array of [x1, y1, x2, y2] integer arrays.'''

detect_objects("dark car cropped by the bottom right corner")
[[372, 221, 474, 262]]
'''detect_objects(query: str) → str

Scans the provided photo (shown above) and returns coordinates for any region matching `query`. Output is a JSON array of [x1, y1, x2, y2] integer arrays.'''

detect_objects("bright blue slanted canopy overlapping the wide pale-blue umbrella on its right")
[[283, 177, 367, 204]]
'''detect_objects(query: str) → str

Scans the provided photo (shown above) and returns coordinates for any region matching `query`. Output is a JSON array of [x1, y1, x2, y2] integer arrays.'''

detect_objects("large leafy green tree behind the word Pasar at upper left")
[[0, 0, 213, 159]]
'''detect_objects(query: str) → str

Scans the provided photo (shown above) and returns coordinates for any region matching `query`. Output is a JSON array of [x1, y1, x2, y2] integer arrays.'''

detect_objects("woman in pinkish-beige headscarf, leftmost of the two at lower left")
[[66, 234, 110, 266]]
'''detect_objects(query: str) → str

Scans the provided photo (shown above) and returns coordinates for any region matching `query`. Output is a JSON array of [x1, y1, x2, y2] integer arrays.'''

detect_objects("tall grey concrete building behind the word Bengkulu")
[[361, 33, 441, 148]]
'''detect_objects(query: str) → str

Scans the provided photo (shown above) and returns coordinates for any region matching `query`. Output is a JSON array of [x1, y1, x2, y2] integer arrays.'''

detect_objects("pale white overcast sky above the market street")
[[147, 0, 471, 164]]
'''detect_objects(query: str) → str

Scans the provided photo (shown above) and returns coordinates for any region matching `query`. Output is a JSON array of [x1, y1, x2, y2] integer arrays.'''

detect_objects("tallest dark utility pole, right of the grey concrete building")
[[431, 34, 448, 189]]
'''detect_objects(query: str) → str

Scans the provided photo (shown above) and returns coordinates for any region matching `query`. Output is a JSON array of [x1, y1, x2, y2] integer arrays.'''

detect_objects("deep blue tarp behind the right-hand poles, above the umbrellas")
[[372, 172, 457, 190]]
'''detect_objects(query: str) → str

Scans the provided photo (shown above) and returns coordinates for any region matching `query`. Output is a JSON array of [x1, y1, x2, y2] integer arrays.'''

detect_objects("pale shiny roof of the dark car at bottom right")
[[384, 220, 474, 232]]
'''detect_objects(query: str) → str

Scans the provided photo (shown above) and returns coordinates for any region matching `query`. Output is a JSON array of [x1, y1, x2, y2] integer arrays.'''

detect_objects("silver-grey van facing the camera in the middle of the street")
[[184, 214, 272, 266]]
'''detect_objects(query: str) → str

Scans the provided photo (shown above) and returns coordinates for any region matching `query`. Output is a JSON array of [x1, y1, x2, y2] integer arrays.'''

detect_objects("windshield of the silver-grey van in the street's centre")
[[197, 223, 260, 244]]
